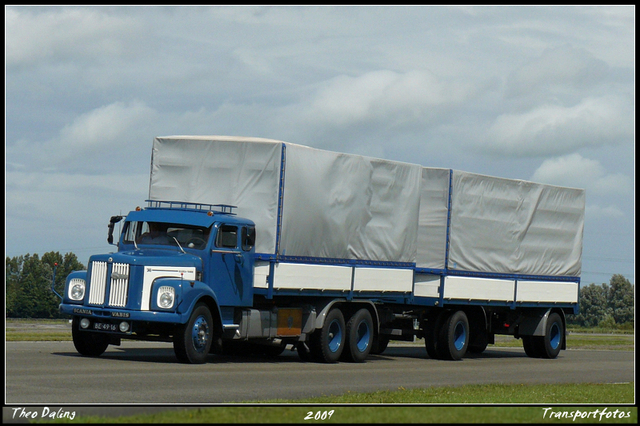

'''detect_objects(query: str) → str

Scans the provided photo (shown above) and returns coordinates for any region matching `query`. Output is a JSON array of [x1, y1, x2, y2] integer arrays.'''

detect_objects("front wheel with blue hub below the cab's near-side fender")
[[173, 303, 214, 364]]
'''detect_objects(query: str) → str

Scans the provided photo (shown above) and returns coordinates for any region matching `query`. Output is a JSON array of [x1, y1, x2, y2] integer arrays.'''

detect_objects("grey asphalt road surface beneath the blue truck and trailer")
[[5, 341, 635, 406]]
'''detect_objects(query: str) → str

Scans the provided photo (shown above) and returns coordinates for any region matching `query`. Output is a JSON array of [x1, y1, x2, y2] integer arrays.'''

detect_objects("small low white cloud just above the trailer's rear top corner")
[[531, 153, 633, 195]]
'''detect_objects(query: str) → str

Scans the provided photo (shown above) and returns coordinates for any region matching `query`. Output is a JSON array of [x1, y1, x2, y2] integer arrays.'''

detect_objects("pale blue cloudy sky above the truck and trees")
[[5, 6, 635, 285]]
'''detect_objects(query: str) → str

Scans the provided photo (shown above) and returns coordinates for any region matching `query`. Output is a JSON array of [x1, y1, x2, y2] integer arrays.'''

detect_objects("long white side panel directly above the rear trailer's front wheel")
[[444, 277, 515, 302]]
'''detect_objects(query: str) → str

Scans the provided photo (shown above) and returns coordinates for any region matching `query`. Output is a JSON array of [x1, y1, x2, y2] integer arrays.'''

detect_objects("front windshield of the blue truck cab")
[[123, 222, 211, 250]]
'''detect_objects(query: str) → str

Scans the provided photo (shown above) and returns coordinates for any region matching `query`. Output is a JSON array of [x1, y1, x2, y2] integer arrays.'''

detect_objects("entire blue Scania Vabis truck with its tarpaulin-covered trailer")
[[55, 136, 585, 363]]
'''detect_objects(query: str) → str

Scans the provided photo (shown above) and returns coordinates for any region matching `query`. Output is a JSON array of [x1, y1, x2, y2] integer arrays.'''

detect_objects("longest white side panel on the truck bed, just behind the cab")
[[273, 263, 352, 291]]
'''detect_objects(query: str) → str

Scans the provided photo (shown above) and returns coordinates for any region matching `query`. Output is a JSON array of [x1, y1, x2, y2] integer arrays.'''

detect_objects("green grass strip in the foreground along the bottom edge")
[[38, 383, 638, 424]]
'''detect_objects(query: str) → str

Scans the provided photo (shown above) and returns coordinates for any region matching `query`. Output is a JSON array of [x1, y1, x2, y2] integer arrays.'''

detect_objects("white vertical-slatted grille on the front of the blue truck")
[[89, 262, 129, 308]]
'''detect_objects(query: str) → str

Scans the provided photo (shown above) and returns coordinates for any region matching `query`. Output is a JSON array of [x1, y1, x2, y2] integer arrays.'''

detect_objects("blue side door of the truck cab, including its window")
[[209, 223, 255, 306]]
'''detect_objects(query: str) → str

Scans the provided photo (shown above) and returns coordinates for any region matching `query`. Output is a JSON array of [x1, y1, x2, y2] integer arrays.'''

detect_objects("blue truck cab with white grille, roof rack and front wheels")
[[60, 201, 256, 363]]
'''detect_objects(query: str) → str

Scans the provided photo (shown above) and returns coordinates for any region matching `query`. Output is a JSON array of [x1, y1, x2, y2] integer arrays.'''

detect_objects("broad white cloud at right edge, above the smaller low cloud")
[[484, 96, 633, 157]]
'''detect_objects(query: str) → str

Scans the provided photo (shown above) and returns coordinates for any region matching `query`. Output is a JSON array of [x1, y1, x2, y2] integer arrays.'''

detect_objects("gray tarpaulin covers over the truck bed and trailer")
[[149, 136, 585, 276]]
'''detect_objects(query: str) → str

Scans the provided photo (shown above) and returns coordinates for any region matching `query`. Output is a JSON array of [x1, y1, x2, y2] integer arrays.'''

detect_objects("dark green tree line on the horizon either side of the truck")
[[5, 252, 634, 328]]
